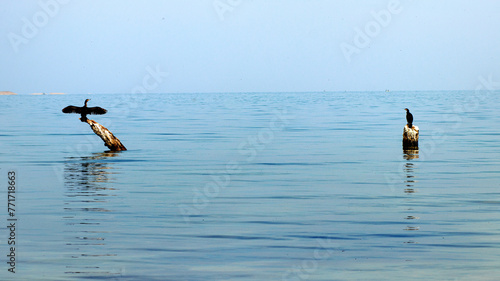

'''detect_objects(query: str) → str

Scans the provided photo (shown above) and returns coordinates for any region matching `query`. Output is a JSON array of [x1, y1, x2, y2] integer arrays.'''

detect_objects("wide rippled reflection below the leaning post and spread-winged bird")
[[63, 152, 119, 276]]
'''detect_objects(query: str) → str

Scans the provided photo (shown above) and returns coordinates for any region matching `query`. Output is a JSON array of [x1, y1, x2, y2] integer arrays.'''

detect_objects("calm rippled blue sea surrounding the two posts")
[[0, 91, 500, 280]]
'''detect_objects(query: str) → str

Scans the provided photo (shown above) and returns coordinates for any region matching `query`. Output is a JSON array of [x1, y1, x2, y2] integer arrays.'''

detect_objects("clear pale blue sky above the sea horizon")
[[0, 0, 500, 94]]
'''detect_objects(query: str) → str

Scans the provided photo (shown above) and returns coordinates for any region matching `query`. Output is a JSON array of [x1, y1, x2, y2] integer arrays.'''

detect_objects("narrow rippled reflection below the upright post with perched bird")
[[403, 149, 420, 244]]
